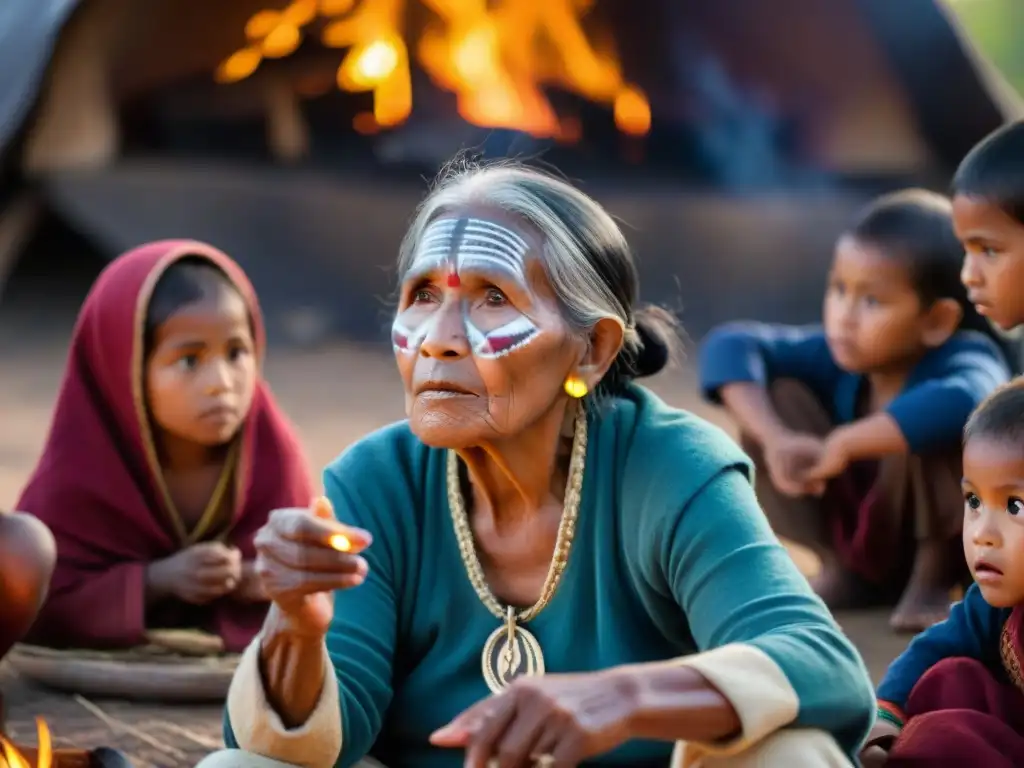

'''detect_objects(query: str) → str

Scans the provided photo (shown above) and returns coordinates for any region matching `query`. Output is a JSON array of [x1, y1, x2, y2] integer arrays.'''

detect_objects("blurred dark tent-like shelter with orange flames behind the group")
[[0, 0, 1024, 343]]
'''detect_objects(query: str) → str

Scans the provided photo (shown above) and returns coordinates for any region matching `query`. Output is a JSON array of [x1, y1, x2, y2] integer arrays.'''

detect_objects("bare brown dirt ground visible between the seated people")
[[0, 318, 902, 768]]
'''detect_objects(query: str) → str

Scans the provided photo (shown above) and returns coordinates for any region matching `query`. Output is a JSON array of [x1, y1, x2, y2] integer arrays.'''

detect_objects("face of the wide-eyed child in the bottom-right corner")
[[964, 435, 1024, 608]]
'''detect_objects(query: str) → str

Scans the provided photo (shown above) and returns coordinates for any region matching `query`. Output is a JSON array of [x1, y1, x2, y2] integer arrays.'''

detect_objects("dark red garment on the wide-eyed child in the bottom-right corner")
[[886, 607, 1024, 768]]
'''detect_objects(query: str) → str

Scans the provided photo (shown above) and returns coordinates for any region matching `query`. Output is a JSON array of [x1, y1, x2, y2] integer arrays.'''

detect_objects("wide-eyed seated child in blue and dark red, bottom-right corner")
[[863, 379, 1024, 768]]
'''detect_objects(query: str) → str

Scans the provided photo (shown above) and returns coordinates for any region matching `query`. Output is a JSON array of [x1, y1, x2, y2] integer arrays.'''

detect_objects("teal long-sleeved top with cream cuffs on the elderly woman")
[[225, 387, 874, 768]]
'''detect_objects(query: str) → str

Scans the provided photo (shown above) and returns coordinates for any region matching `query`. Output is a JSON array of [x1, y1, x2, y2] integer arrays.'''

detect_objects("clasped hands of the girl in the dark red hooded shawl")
[[152, 542, 242, 605]]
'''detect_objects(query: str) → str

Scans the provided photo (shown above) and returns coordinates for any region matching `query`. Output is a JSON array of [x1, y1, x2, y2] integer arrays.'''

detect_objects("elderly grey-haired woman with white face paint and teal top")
[[204, 166, 873, 768]]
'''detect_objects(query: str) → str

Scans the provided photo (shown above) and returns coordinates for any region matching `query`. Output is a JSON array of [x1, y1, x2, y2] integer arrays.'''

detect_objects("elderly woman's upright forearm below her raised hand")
[[260, 605, 325, 728]]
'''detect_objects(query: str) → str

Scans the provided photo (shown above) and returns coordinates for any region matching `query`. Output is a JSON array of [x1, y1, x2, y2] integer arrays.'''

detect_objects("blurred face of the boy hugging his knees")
[[824, 236, 927, 373]]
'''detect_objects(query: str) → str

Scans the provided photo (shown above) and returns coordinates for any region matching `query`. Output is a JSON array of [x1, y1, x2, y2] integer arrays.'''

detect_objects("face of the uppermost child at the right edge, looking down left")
[[953, 195, 1024, 330]]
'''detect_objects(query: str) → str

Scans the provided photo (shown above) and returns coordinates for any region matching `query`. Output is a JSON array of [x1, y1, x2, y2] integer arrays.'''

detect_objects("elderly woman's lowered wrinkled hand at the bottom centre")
[[430, 670, 634, 768]]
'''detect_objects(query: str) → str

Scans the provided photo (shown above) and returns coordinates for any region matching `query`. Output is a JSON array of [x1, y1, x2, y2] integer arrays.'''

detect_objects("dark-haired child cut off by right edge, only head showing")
[[953, 123, 1024, 330]]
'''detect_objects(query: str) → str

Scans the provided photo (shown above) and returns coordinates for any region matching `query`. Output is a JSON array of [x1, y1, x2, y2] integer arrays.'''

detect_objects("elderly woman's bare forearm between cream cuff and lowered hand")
[[623, 663, 742, 743]]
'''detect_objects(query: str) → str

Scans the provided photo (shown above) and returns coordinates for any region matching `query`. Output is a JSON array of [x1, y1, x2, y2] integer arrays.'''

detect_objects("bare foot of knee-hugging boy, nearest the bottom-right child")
[[889, 540, 955, 633]]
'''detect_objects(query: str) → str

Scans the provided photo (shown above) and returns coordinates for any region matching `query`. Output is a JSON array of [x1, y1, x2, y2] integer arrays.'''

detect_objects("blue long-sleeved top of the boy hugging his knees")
[[698, 323, 1011, 454]]
